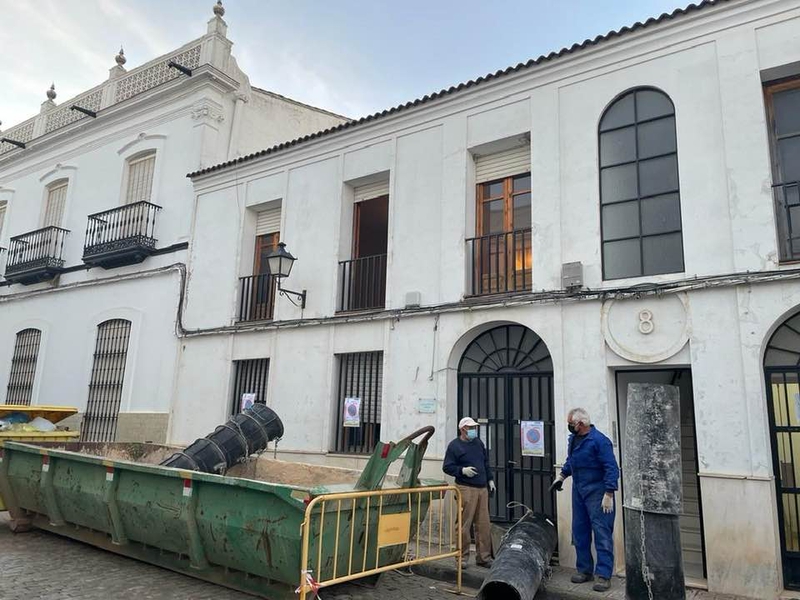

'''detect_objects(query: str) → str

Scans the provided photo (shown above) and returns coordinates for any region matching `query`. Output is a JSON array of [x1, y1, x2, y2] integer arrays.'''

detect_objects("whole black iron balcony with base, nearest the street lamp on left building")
[[83, 202, 161, 269]]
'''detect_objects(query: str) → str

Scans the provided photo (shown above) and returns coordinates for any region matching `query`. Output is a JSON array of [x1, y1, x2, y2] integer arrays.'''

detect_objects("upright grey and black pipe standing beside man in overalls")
[[622, 383, 686, 600]]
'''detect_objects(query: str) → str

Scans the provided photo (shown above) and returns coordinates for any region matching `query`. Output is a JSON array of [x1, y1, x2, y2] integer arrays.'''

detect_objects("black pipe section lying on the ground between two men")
[[478, 512, 558, 600]]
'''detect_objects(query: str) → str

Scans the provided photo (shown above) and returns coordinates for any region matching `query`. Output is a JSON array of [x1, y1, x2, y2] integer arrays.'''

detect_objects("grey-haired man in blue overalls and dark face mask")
[[550, 408, 619, 592]]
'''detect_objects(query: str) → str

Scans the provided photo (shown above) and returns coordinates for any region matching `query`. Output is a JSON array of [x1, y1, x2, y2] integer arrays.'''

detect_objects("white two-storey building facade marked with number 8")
[[180, 0, 800, 598]]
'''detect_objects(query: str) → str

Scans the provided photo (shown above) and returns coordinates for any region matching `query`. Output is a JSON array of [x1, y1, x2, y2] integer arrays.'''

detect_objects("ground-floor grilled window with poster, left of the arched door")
[[334, 352, 383, 454]]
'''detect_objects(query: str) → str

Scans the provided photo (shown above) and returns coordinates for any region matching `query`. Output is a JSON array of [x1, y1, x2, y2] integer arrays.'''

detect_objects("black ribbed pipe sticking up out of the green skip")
[[161, 404, 283, 475]]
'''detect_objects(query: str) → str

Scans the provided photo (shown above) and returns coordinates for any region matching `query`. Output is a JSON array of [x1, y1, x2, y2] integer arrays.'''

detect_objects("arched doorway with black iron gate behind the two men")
[[458, 325, 556, 522]]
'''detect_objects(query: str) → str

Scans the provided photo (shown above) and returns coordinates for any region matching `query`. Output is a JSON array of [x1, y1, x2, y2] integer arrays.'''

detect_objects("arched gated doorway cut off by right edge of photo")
[[764, 313, 800, 590]]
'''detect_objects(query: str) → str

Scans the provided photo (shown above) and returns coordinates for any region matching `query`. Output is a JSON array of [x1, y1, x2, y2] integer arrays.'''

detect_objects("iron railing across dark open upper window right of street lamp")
[[339, 254, 387, 312]]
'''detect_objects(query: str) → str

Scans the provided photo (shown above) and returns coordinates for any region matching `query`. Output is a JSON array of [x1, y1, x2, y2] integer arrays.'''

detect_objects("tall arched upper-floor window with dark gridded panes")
[[599, 89, 684, 279]]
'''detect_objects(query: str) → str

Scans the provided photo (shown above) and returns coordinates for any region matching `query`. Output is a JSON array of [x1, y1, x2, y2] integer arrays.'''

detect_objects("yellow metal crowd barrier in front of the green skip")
[[297, 485, 461, 600]]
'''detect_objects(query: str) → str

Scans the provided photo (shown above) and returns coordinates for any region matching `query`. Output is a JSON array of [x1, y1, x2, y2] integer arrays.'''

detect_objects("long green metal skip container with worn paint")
[[0, 428, 440, 600]]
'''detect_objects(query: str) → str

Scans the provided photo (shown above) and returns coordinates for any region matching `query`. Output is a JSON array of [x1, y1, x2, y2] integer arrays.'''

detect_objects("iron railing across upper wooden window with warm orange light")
[[467, 229, 533, 296]]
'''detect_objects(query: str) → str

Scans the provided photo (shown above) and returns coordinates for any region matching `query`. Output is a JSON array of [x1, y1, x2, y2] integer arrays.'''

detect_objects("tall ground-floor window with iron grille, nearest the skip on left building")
[[81, 319, 131, 442]]
